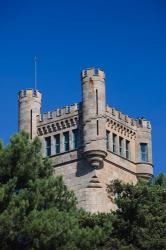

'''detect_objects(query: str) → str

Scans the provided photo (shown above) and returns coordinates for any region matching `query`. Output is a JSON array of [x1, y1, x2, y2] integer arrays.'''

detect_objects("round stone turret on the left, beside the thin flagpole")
[[18, 89, 42, 139]]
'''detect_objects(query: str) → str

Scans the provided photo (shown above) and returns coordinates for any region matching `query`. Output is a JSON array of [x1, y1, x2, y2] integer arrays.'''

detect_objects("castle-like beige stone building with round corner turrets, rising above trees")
[[19, 68, 153, 212]]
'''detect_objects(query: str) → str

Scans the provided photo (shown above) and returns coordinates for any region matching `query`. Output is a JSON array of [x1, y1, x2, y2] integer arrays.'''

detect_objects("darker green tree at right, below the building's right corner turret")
[[105, 174, 166, 250]]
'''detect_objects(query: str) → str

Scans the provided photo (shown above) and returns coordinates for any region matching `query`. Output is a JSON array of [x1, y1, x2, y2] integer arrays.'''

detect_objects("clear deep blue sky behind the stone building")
[[0, 0, 166, 174]]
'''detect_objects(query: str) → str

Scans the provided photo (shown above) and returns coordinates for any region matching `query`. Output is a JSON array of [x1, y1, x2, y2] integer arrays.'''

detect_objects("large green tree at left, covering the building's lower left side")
[[0, 132, 112, 250]]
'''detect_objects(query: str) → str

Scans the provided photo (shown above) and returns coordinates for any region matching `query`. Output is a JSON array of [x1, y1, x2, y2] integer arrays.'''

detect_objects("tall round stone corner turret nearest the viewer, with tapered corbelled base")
[[81, 68, 107, 168]]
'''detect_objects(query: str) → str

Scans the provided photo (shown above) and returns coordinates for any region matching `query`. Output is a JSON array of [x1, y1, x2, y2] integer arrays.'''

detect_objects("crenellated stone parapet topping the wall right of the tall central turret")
[[106, 105, 151, 129]]
